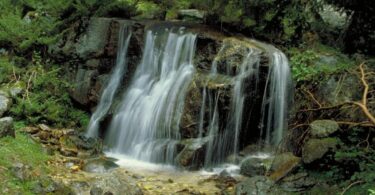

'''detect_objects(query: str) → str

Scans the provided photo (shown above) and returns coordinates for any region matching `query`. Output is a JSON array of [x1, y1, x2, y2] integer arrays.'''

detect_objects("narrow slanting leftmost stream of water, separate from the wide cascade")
[[86, 23, 132, 137]]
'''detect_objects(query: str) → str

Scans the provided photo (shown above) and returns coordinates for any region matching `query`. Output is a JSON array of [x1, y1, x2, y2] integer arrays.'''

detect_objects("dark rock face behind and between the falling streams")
[[50, 17, 276, 167]]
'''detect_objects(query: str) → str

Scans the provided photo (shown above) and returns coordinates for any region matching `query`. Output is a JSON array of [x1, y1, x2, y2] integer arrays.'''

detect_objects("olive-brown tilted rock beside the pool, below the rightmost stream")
[[269, 152, 301, 181]]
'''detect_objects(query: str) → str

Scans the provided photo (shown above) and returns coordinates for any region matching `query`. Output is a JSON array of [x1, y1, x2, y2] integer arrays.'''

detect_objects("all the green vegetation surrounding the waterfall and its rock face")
[[0, 0, 375, 194]]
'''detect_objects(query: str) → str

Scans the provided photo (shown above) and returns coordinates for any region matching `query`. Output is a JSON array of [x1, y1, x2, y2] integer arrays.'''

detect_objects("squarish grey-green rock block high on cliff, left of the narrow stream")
[[76, 18, 111, 59]]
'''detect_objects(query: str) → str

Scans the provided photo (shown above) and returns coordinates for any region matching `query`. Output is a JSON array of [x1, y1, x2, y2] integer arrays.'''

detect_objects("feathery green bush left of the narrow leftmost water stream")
[[7, 53, 89, 128]]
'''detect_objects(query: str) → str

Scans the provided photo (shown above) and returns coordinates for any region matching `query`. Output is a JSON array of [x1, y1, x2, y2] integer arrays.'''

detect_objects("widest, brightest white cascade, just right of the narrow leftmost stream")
[[105, 28, 196, 164]]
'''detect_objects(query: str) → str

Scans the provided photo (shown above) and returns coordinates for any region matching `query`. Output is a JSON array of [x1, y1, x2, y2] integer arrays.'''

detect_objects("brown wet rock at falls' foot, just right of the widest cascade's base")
[[176, 137, 211, 169]]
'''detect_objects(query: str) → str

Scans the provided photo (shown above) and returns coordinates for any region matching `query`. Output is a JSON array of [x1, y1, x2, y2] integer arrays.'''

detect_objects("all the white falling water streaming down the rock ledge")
[[87, 21, 291, 167]]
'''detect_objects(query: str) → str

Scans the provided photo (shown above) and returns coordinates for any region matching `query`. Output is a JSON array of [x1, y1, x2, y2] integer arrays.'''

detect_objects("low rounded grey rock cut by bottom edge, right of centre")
[[236, 176, 280, 195]]
